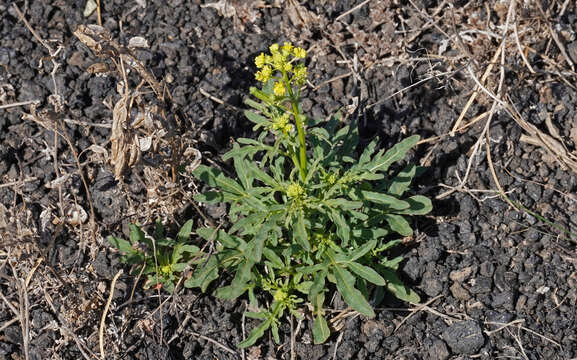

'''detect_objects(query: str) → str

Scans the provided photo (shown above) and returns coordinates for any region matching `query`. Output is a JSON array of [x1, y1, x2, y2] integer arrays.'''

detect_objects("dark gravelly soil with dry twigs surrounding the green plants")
[[0, 0, 577, 359]]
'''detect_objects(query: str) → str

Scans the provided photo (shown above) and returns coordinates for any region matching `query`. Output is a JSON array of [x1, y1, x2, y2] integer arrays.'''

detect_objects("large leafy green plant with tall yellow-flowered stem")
[[190, 43, 431, 347]]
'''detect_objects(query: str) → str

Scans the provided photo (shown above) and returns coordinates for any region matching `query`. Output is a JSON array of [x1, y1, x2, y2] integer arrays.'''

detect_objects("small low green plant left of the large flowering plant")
[[108, 220, 200, 293]]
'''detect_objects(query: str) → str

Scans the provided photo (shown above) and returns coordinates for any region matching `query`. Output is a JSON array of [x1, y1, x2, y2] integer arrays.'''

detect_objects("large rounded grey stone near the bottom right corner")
[[443, 321, 485, 355]]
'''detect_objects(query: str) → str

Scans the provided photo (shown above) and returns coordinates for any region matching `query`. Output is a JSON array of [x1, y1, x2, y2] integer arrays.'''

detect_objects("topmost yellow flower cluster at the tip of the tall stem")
[[254, 42, 307, 96]]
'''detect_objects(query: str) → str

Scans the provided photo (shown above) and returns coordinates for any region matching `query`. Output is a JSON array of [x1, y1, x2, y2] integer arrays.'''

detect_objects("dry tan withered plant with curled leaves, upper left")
[[74, 25, 199, 181]]
